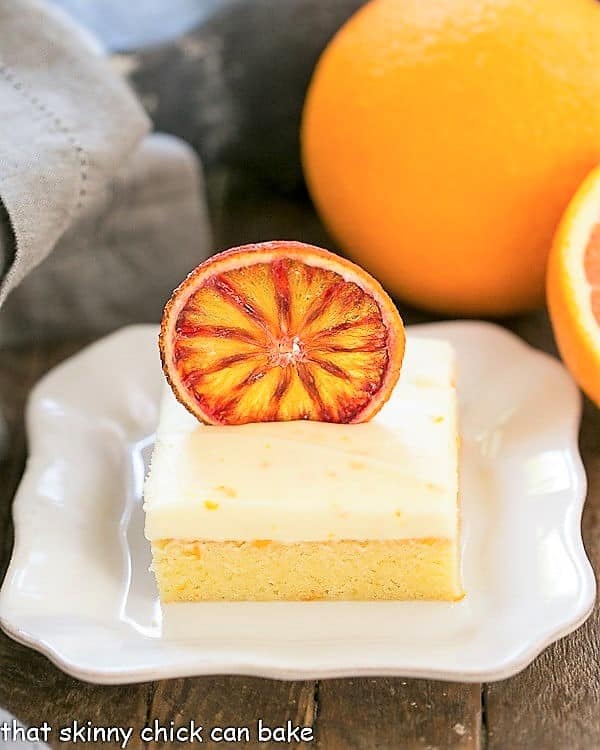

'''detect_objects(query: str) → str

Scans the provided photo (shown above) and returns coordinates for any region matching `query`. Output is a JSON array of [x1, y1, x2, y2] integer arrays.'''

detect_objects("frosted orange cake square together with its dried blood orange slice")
[[144, 243, 462, 602]]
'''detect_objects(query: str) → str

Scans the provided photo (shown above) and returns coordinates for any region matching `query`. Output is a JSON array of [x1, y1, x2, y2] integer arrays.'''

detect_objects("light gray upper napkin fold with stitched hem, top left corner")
[[0, 0, 149, 304]]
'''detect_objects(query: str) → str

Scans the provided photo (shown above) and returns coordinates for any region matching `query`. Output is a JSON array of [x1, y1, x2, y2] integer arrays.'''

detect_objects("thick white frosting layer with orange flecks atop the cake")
[[144, 337, 458, 542]]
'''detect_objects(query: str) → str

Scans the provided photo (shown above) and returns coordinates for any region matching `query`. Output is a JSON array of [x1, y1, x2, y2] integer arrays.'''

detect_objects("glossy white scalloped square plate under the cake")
[[0, 322, 595, 683]]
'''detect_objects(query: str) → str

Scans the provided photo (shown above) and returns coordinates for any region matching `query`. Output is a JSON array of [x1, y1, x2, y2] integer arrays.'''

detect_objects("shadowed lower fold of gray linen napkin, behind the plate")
[[0, 134, 210, 344]]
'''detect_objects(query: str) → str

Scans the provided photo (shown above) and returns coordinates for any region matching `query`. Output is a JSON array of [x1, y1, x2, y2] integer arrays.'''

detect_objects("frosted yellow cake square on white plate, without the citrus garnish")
[[145, 339, 461, 602]]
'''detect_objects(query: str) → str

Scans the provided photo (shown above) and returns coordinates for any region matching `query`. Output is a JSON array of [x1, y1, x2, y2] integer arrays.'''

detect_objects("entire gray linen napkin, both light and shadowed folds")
[[0, 0, 210, 343]]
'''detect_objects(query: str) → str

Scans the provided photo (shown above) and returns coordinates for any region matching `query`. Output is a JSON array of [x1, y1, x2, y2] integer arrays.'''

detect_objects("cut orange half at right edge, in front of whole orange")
[[546, 167, 600, 406]]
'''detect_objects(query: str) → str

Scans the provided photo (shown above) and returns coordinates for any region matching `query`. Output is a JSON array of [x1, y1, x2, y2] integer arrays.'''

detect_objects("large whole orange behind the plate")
[[301, 0, 600, 315]]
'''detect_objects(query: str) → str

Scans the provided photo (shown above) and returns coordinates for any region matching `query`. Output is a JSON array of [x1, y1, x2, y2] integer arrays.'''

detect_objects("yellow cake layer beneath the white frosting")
[[152, 538, 463, 602]]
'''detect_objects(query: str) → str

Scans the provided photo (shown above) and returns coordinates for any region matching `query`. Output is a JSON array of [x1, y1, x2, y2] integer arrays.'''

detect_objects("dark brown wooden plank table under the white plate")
[[0, 187, 600, 750]]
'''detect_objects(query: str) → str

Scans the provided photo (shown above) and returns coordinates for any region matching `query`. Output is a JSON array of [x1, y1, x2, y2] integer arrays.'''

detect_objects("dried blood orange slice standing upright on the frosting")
[[160, 241, 404, 425]]
